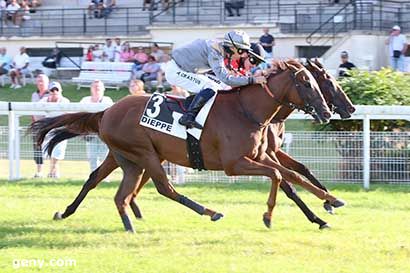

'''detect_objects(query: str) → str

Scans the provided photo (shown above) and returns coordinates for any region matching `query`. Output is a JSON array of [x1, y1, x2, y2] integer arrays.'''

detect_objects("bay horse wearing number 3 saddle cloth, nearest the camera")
[[32, 60, 339, 231]]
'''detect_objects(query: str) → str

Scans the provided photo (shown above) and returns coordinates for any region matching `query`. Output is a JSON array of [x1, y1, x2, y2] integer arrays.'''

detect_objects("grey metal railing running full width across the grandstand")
[[0, 0, 410, 38]]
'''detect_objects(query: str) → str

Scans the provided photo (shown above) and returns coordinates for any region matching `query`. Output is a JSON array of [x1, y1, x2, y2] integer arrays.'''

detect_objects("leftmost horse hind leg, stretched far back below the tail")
[[54, 152, 118, 220]]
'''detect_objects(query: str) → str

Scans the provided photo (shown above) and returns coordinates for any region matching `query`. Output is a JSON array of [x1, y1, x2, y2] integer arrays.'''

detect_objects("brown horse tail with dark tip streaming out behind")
[[30, 111, 104, 155]]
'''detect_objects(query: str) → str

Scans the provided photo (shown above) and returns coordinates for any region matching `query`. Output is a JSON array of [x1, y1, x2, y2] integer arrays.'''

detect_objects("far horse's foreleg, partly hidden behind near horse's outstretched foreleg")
[[276, 149, 342, 214]]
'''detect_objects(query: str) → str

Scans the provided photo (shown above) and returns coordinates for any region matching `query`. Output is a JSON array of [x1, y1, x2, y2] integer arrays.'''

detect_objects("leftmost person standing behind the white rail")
[[31, 74, 49, 178]]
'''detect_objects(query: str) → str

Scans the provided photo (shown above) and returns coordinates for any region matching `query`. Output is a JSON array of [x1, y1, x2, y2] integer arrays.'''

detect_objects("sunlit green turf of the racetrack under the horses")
[[0, 180, 410, 273]]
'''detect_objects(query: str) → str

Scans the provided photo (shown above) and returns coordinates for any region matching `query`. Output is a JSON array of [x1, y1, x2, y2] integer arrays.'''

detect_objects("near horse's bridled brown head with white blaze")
[[268, 60, 331, 123]]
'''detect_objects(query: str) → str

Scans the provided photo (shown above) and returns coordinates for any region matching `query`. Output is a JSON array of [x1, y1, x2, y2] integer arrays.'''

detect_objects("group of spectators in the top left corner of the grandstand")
[[0, 0, 42, 28]]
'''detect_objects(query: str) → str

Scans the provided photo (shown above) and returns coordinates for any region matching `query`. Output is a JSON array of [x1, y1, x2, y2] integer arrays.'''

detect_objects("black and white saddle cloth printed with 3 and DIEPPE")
[[140, 93, 216, 140]]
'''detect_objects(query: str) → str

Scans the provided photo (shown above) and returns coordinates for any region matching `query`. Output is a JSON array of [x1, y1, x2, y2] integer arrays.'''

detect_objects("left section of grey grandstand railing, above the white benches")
[[0, 7, 150, 37]]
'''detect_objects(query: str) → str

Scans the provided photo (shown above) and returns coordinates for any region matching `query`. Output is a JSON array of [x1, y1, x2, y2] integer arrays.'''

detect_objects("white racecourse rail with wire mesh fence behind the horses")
[[0, 102, 410, 188]]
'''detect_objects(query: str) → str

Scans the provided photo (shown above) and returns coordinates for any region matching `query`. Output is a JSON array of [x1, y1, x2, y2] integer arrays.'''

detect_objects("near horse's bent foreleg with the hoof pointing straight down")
[[225, 156, 282, 228]]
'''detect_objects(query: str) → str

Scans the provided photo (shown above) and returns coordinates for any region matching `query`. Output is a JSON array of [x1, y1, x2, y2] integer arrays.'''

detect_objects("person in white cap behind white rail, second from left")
[[39, 82, 70, 178]]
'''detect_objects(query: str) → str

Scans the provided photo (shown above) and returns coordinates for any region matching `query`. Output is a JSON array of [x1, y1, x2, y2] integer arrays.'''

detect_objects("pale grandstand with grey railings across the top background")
[[0, 0, 410, 73]]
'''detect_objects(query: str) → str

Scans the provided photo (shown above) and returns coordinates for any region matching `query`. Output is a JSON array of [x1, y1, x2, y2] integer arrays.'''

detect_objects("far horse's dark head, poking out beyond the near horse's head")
[[306, 59, 356, 119]]
